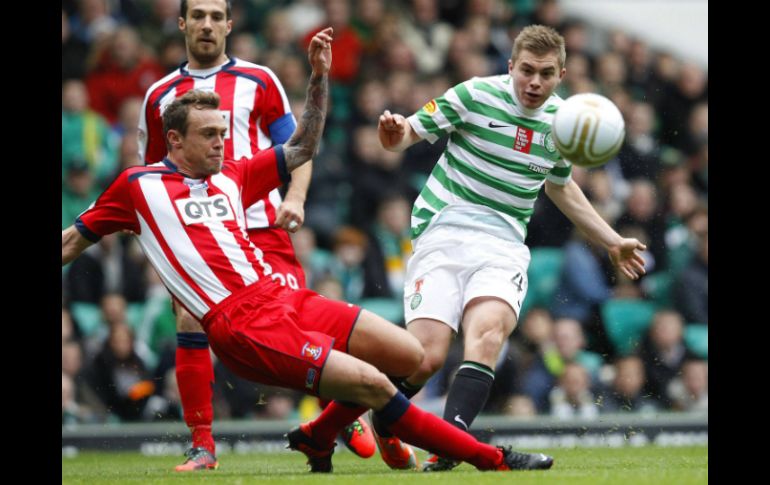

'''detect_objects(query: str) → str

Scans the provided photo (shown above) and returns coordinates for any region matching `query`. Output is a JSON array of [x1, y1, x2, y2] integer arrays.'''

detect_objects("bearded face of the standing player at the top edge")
[[179, 0, 233, 68]]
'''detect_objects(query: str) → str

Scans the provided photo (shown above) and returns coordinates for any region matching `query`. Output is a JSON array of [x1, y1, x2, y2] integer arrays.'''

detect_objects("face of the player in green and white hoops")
[[508, 50, 567, 109]]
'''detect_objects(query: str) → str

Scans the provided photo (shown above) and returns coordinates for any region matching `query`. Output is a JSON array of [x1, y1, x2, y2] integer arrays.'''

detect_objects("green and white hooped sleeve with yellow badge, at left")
[[407, 81, 475, 143]]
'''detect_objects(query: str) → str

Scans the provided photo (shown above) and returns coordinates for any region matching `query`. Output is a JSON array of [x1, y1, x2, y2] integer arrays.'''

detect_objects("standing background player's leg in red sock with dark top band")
[[173, 299, 219, 471]]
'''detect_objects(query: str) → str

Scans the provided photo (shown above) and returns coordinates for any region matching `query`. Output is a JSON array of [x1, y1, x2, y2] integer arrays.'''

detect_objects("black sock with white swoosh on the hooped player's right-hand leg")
[[444, 360, 495, 431]]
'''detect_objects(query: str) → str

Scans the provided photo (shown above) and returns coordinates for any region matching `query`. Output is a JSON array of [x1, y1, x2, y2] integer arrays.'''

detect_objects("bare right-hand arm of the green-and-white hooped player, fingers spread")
[[545, 180, 647, 280]]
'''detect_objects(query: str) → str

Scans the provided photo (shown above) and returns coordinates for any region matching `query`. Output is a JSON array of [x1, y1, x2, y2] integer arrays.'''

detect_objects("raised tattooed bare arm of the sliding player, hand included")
[[283, 27, 333, 172]]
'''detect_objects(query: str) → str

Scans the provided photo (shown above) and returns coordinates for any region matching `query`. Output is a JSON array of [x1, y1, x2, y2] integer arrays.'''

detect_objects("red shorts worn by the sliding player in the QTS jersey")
[[202, 278, 361, 395]]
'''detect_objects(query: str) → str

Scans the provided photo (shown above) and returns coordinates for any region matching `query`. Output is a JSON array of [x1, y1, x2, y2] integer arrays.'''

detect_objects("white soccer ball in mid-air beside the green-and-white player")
[[552, 93, 626, 168]]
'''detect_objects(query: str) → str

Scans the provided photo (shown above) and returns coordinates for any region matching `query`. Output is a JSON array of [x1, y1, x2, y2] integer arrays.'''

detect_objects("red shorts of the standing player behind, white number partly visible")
[[247, 227, 305, 290]]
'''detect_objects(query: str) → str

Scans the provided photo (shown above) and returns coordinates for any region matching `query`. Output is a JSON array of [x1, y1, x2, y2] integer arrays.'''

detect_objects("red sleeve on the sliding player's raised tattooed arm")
[[233, 145, 291, 207]]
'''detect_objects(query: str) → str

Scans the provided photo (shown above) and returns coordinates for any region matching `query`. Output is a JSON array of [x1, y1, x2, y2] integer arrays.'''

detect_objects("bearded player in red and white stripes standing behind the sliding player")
[[138, 0, 312, 471]]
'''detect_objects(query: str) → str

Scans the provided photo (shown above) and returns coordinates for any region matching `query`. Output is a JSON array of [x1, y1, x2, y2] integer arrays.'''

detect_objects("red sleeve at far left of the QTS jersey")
[[75, 171, 140, 242]]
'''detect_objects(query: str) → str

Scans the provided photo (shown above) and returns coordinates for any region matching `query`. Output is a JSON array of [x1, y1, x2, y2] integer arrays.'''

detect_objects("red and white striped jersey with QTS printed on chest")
[[75, 145, 289, 320]]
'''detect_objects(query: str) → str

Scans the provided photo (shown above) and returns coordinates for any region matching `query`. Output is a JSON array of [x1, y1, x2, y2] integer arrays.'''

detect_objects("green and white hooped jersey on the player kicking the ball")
[[408, 74, 572, 243]]
